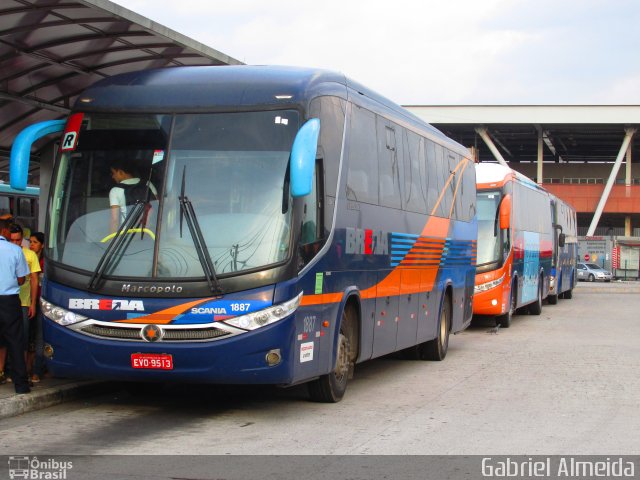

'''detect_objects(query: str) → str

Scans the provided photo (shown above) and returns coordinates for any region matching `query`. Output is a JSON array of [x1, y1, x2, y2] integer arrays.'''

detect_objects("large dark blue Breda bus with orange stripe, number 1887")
[[12, 66, 477, 402]]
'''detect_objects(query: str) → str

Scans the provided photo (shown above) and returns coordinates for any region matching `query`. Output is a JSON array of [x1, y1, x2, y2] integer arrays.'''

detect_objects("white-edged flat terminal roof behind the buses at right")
[[407, 105, 640, 164]]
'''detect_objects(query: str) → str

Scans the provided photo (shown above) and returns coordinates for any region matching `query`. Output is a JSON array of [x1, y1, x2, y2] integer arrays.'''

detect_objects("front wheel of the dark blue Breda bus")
[[307, 308, 355, 403]]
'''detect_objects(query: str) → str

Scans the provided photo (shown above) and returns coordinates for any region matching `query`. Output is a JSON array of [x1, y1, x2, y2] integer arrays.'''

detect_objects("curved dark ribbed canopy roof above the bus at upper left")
[[0, 0, 242, 183]]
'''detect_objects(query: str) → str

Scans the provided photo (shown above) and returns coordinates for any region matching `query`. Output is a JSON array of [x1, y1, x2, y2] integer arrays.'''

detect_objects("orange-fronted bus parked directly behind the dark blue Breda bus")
[[473, 163, 554, 327]]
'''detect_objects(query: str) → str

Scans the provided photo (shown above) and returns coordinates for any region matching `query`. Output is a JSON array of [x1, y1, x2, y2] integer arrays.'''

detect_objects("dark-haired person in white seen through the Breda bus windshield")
[[109, 158, 158, 233]]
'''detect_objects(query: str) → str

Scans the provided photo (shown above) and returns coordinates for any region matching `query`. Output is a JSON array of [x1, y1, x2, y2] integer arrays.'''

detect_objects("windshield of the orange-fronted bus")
[[477, 190, 502, 265]]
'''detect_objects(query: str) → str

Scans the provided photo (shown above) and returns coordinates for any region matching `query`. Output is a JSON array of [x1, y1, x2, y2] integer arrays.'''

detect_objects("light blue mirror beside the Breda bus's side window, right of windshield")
[[290, 118, 320, 198]]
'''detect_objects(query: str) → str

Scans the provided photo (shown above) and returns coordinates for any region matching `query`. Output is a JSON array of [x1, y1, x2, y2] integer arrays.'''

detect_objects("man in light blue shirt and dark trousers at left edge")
[[0, 220, 31, 393]]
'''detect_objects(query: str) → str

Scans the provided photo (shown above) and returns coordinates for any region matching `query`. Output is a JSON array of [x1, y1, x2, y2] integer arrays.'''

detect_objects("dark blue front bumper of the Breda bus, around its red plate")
[[43, 316, 295, 385]]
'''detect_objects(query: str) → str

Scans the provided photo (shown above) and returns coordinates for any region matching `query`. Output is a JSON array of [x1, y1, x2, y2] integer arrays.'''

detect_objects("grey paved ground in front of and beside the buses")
[[0, 282, 640, 455]]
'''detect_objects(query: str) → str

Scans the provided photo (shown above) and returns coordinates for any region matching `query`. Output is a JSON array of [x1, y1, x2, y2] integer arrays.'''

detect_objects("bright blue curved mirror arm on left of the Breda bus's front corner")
[[9, 119, 67, 190]]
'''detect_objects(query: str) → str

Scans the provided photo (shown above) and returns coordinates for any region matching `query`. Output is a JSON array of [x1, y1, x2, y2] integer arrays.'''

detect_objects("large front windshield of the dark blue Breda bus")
[[49, 110, 299, 278]]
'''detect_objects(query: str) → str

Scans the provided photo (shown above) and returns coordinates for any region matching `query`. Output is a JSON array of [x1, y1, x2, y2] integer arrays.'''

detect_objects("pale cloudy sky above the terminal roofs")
[[115, 0, 640, 105]]
